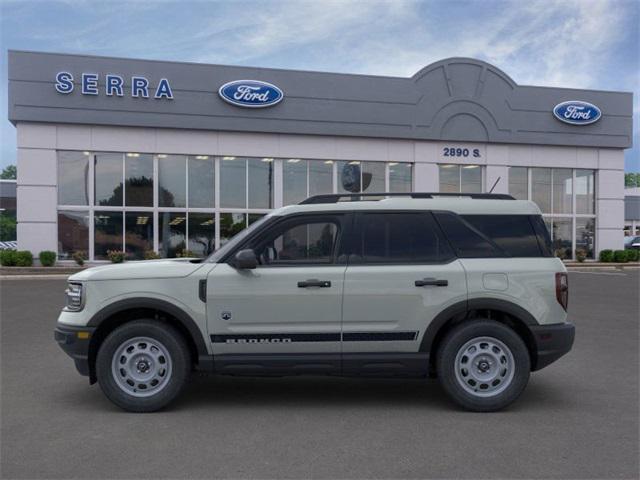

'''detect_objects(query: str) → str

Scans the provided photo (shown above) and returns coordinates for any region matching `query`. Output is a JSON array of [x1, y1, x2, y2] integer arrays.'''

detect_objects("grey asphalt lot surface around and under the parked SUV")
[[0, 270, 640, 478]]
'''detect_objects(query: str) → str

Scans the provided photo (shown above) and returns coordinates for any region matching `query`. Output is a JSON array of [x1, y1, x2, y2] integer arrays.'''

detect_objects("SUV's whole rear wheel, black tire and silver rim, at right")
[[436, 320, 531, 412]]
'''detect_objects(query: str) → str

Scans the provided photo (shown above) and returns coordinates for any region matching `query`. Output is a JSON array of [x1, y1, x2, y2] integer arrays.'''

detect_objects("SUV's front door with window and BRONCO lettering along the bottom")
[[207, 214, 348, 373]]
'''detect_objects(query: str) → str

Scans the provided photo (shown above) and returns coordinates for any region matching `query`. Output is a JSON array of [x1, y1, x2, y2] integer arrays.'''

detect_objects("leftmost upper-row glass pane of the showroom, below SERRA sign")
[[58, 151, 91, 205]]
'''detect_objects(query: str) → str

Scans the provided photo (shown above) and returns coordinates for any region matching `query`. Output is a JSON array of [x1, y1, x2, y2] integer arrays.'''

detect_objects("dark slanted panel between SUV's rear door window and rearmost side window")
[[435, 213, 504, 258]]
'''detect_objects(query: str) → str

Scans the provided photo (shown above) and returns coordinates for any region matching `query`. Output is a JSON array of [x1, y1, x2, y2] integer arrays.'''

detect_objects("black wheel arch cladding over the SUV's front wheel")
[[88, 298, 209, 383]]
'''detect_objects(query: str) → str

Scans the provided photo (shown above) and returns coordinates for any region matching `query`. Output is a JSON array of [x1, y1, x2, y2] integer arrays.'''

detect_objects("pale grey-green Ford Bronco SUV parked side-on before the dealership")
[[55, 193, 574, 412]]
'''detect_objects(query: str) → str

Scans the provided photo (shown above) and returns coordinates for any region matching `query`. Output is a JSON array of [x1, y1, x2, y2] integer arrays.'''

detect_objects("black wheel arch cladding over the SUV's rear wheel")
[[420, 298, 539, 374]]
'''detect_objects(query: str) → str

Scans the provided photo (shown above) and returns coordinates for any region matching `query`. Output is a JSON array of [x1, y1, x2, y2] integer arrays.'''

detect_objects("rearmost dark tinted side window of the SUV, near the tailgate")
[[463, 215, 541, 257]]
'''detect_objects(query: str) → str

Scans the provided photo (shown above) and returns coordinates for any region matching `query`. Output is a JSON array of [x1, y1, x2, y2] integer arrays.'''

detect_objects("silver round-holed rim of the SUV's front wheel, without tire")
[[111, 337, 172, 397]]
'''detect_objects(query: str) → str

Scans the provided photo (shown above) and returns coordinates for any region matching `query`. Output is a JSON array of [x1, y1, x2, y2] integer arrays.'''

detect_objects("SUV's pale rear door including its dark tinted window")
[[342, 211, 467, 373]]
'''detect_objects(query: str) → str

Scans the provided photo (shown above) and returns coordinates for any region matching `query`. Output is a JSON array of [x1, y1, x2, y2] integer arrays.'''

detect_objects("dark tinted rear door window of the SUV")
[[353, 213, 453, 263]]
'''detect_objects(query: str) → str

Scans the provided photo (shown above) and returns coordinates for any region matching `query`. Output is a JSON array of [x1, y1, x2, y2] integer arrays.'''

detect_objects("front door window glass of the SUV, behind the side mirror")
[[254, 219, 339, 265]]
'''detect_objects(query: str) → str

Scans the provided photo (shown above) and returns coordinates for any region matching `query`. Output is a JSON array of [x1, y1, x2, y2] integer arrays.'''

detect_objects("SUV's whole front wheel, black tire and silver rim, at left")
[[96, 320, 191, 412]]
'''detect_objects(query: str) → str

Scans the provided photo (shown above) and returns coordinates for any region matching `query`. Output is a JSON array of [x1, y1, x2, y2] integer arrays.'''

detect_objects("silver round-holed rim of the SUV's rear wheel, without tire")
[[455, 337, 515, 397]]
